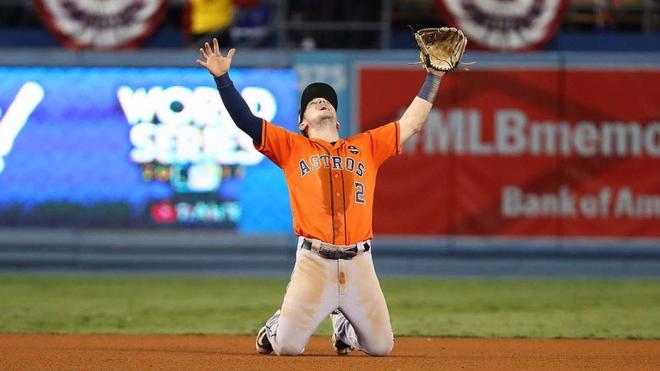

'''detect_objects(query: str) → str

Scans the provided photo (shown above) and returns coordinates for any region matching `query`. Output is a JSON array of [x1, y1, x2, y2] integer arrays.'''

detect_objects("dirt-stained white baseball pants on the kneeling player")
[[266, 238, 394, 356]]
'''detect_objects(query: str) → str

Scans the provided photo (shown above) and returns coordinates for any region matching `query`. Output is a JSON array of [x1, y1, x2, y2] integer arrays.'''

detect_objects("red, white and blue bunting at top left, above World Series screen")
[[35, 0, 168, 49]]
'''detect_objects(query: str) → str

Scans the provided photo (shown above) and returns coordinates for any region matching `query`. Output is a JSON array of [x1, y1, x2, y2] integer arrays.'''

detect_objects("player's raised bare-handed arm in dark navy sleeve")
[[196, 38, 263, 143]]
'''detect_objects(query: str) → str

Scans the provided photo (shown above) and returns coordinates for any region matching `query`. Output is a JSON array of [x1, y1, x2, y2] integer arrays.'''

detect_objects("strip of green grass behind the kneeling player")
[[0, 275, 660, 339]]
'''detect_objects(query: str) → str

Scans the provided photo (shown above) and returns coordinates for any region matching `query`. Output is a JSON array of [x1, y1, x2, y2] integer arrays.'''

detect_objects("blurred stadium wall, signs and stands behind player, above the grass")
[[0, 0, 660, 277]]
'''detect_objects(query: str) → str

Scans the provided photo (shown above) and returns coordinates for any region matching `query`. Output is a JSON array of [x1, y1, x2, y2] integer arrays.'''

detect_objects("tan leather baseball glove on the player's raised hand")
[[415, 27, 467, 71]]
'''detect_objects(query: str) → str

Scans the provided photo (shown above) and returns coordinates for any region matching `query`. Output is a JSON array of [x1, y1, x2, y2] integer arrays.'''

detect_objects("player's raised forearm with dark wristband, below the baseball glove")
[[399, 70, 445, 143]]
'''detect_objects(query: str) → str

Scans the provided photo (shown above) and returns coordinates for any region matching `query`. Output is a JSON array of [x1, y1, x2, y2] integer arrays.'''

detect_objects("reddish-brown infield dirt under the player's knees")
[[0, 335, 660, 371]]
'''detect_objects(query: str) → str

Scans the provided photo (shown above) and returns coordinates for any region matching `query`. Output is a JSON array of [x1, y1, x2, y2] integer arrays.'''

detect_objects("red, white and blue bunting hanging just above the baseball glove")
[[436, 0, 570, 51]]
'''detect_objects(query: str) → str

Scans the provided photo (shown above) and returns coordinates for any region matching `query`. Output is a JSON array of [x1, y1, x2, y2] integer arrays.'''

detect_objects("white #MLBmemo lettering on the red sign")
[[402, 109, 660, 158]]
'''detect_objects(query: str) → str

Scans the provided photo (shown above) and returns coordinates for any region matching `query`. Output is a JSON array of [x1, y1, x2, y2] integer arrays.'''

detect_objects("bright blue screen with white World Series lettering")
[[0, 67, 298, 233]]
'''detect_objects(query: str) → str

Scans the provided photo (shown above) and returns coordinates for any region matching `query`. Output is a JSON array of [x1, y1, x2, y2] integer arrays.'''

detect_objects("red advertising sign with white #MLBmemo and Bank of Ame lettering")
[[357, 67, 660, 238]]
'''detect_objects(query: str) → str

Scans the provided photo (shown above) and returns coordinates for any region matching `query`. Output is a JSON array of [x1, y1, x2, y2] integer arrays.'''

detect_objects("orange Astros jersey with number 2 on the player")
[[255, 120, 401, 245]]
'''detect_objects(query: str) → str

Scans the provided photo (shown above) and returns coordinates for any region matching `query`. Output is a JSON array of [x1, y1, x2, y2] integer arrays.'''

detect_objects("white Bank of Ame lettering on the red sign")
[[501, 186, 660, 219]]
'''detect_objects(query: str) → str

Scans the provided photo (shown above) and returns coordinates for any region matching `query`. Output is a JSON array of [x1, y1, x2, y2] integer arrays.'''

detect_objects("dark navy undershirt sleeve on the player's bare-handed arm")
[[215, 73, 263, 144]]
